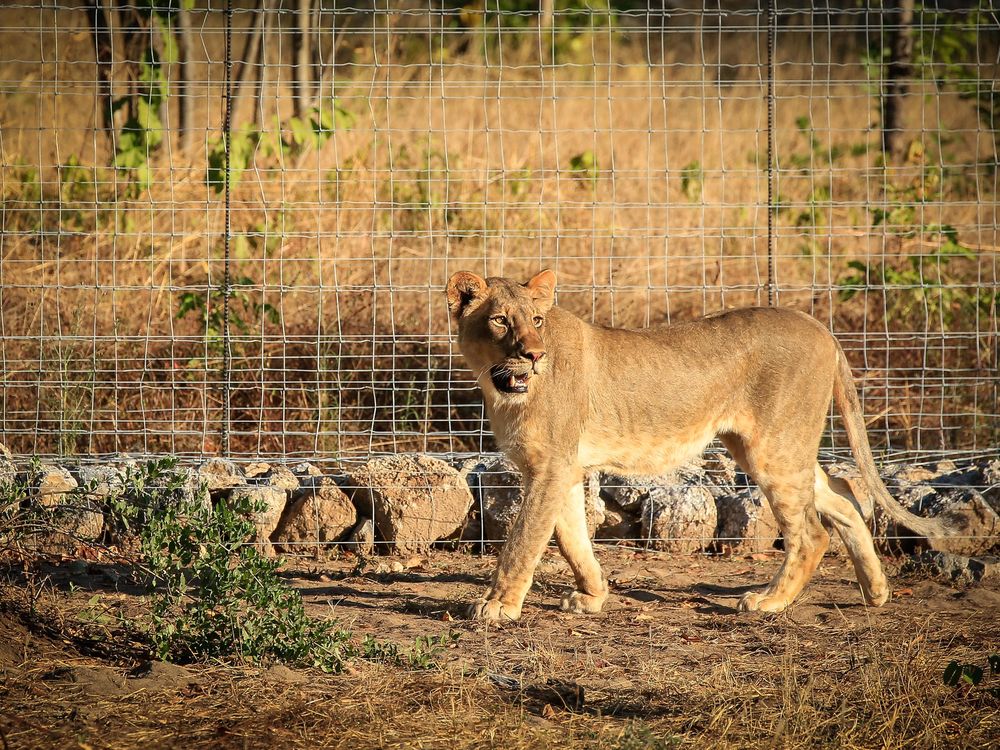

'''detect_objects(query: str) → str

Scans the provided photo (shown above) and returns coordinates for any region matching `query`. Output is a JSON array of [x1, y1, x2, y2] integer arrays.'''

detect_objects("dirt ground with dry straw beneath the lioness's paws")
[[0, 548, 1000, 750]]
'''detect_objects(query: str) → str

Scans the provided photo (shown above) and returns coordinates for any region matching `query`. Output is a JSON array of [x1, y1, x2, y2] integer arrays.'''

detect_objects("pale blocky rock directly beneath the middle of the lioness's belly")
[[641, 486, 718, 552]]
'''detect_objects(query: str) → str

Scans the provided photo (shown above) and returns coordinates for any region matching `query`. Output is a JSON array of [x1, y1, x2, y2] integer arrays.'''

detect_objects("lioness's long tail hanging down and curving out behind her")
[[833, 342, 955, 538]]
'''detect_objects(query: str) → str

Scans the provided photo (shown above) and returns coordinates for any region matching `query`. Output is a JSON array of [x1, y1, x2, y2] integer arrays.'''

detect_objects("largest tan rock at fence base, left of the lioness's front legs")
[[349, 455, 472, 553]]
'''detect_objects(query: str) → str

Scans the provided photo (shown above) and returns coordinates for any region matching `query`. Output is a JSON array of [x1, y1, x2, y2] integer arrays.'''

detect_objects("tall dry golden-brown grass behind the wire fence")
[[2, 5, 998, 456]]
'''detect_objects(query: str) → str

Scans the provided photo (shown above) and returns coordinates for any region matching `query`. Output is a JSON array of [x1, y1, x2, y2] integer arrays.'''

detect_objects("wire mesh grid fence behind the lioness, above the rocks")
[[0, 0, 1000, 470]]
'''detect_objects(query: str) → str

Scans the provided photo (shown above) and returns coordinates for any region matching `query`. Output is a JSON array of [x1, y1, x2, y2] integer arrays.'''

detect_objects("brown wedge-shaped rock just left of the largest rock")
[[271, 474, 357, 554]]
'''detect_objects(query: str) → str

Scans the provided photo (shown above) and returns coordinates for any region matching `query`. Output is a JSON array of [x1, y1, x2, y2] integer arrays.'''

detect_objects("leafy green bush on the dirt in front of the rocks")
[[123, 460, 353, 672]]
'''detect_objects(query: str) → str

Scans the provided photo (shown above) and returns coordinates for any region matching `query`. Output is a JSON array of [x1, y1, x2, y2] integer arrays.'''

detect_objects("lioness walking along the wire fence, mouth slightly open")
[[447, 270, 947, 620]]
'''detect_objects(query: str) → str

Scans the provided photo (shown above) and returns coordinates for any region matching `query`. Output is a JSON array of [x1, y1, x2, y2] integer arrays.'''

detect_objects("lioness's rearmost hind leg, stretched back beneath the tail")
[[815, 464, 889, 607]]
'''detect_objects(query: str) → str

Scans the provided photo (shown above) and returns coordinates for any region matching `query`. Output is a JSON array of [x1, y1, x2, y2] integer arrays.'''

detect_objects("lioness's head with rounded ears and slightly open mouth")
[[448, 270, 556, 394]]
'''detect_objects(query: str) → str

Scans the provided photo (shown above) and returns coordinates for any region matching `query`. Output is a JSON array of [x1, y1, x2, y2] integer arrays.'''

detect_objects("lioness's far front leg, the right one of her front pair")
[[556, 483, 608, 614]]
